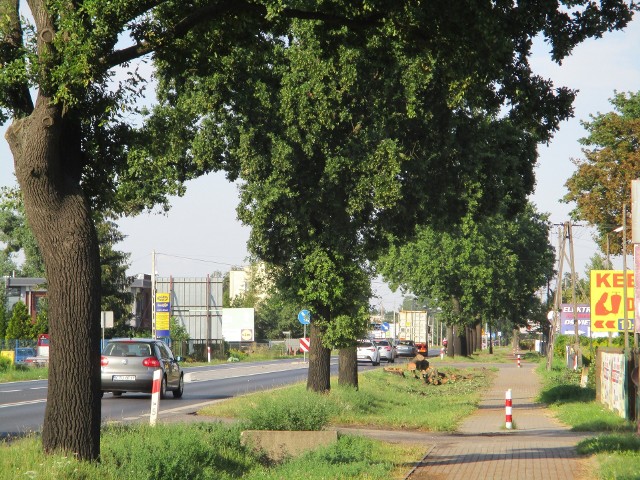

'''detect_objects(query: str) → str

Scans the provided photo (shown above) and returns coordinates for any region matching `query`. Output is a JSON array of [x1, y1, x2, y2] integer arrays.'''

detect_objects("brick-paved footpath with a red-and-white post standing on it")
[[406, 362, 589, 480]]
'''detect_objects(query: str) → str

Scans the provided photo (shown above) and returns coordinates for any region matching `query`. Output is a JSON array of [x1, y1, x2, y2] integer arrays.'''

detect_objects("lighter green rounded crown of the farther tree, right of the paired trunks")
[[378, 202, 554, 334]]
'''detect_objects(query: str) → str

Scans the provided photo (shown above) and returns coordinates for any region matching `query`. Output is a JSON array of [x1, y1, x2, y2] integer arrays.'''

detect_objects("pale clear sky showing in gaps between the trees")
[[0, 18, 640, 310]]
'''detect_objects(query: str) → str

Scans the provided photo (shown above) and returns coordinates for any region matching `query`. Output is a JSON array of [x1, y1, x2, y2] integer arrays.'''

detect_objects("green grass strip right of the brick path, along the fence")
[[538, 357, 640, 480]]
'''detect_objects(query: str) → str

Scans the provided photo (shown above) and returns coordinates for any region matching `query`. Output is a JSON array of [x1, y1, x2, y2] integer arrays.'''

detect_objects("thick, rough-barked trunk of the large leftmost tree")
[[6, 97, 101, 459]]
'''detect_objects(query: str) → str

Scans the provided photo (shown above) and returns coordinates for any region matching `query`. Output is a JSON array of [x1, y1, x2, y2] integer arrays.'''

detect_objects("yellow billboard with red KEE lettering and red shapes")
[[591, 270, 634, 332]]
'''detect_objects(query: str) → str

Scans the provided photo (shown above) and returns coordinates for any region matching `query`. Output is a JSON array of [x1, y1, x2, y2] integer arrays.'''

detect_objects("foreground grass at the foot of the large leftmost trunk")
[[0, 423, 427, 480]]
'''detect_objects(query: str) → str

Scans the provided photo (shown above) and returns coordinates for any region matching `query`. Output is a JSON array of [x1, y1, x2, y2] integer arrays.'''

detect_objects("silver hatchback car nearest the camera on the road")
[[100, 338, 184, 398]]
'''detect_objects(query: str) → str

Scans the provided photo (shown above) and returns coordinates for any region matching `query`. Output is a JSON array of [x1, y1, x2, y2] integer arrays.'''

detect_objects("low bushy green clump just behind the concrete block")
[[243, 392, 335, 431]]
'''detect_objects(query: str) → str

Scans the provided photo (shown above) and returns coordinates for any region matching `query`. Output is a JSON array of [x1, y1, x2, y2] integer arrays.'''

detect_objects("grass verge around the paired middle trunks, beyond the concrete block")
[[199, 368, 494, 432]]
